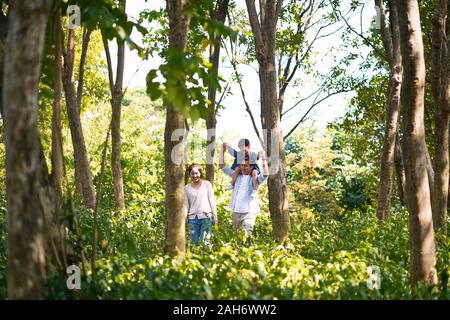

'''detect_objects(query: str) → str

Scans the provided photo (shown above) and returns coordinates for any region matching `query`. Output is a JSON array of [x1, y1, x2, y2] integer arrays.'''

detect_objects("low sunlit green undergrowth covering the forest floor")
[[59, 210, 450, 299]]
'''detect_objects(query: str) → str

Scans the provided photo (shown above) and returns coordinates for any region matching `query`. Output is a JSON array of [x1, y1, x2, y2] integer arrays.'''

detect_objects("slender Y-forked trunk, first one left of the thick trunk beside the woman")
[[102, 0, 126, 210]]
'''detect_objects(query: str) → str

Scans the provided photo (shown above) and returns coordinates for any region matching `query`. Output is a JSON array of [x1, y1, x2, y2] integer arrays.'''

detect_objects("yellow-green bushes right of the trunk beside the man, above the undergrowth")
[[286, 123, 374, 219]]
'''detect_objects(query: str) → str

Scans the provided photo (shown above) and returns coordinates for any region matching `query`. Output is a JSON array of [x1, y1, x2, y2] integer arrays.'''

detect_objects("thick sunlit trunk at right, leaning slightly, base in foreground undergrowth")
[[398, 0, 437, 284]]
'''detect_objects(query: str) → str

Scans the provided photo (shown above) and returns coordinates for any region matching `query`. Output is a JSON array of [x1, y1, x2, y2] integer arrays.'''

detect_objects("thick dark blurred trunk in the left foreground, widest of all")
[[3, 0, 51, 299]]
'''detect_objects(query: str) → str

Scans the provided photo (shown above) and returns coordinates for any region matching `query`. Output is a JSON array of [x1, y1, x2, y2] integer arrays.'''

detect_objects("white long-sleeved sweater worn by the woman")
[[184, 180, 217, 220]]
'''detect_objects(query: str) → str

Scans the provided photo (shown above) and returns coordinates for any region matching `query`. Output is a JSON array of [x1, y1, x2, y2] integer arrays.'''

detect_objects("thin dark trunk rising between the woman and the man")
[[206, 0, 230, 185]]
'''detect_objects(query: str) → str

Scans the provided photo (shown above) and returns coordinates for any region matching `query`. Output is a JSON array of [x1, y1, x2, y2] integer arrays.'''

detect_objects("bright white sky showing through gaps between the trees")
[[112, 0, 376, 150]]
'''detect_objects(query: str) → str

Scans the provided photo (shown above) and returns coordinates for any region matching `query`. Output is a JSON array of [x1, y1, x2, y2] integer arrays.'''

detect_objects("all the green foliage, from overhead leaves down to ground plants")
[[0, 0, 450, 299]]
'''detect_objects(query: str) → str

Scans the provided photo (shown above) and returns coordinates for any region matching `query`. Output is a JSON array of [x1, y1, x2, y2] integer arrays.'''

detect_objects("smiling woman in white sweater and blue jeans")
[[184, 163, 219, 247]]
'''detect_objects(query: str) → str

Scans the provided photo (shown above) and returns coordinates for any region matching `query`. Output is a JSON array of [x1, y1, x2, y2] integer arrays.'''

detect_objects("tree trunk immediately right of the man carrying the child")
[[246, 0, 290, 241]]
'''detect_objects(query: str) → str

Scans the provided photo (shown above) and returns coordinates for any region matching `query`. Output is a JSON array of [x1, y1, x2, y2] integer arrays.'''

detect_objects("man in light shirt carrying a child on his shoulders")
[[219, 145, 269, 236]]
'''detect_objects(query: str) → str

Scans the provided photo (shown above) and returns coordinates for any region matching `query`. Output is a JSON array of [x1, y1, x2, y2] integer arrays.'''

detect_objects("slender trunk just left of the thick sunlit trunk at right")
[[375, 1, 403, 221]]
